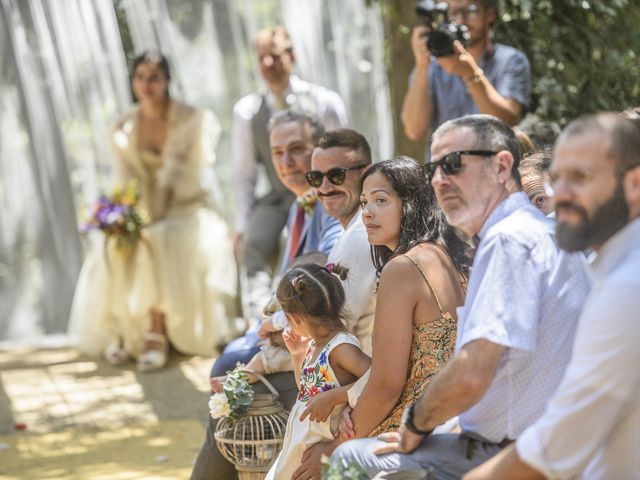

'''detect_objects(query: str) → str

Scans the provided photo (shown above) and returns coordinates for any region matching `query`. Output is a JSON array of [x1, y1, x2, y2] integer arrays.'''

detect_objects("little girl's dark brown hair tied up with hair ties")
[[276, 263, 349, 331]]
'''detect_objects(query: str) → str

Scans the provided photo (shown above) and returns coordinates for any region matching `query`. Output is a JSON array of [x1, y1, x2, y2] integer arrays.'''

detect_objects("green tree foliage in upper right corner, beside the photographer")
[[495, 0, 640, 125]]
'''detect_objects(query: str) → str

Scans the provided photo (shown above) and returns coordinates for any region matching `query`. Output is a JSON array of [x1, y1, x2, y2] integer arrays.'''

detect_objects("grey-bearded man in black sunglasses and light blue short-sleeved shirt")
[[336, 115, 590, 479]]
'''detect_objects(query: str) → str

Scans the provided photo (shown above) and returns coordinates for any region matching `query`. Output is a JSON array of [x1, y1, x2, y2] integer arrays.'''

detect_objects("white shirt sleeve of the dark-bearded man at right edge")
[[516, 281, 640, 479]]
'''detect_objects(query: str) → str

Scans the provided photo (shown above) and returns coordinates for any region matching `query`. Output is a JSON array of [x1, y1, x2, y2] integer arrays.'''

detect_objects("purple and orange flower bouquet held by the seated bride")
[[82, 181, 149, 247]]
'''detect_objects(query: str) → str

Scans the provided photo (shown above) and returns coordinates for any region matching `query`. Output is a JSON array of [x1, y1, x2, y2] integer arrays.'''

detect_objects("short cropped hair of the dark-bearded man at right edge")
[[556, 112, 640, 172]]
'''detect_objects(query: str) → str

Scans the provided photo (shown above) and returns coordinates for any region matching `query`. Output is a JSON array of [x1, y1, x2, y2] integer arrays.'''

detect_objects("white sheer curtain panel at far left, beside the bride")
[[0, 0, 130, 340]]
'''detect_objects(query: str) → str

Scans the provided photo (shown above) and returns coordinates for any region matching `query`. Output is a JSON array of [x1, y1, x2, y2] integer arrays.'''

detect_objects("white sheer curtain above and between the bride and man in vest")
[[117, 0, 393, 203]]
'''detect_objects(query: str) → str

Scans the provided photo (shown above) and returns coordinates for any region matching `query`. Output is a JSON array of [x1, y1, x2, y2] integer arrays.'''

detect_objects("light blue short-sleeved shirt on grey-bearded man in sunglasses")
[[456, 192, 590, 442]]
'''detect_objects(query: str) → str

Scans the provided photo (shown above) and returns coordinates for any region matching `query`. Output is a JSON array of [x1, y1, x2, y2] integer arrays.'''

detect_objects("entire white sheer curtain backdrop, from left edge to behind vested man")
[[0, 0, 393, 340]]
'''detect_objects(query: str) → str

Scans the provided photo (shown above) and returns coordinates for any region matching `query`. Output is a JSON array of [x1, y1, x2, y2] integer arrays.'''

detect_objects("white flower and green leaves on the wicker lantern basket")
[[209, 363, 253, 419]]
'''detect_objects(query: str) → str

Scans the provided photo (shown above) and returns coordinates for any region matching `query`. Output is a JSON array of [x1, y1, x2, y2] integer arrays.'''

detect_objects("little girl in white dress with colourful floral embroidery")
[[266, 264, 371, 480]]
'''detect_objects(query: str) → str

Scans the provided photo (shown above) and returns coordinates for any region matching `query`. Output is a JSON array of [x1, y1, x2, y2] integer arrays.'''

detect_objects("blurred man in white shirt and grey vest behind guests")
[[231, 26, 348, 316]]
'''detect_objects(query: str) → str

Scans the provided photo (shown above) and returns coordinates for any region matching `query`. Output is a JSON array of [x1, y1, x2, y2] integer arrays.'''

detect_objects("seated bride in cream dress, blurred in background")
[[71, 52, 236, 371]]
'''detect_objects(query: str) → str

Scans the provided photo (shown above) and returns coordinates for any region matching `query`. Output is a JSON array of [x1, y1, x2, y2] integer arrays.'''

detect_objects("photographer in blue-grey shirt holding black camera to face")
[[401, 0, 531, 157]]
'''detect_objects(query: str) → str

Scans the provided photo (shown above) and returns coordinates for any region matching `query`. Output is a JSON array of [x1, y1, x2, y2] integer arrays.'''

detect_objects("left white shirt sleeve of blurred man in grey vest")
[[231, 97, 258, 233]]
